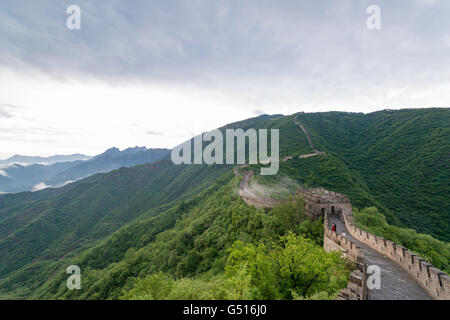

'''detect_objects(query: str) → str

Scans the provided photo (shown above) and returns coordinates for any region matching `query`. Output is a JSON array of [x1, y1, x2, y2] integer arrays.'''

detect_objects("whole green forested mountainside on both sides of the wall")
[[0, 109, 450, 299]]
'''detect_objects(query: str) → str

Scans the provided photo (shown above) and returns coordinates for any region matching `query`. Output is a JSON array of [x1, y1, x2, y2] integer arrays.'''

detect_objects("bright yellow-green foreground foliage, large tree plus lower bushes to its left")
[[122, 233, 349, 300]]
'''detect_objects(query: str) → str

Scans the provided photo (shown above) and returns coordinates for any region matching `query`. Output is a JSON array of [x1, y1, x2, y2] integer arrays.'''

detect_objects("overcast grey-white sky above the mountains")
[[0, 0, 450, 158]]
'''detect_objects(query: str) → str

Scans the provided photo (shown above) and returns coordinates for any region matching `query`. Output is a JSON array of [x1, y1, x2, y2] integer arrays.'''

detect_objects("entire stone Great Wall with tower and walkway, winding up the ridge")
[[235, 118, 450, 300]]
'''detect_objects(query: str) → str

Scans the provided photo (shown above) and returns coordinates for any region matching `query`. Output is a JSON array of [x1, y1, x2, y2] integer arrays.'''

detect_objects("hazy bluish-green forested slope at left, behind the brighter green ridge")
[[0, 160, 232, 275]]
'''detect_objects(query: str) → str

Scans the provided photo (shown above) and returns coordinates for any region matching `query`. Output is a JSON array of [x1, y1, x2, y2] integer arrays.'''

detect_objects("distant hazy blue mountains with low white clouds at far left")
[[0, 147, 170, 193]]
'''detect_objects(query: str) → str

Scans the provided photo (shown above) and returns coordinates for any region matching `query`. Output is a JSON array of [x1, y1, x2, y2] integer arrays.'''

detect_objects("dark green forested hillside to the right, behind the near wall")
[[253, 109, 450, 241]]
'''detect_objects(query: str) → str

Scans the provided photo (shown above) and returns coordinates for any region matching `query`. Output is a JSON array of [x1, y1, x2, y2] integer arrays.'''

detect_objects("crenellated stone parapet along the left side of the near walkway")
[[323, 214, 367, 300]]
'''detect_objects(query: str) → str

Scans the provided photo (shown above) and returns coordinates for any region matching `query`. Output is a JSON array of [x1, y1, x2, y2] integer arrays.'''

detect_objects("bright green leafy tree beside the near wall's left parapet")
[[225, 232, 350, 299]]
